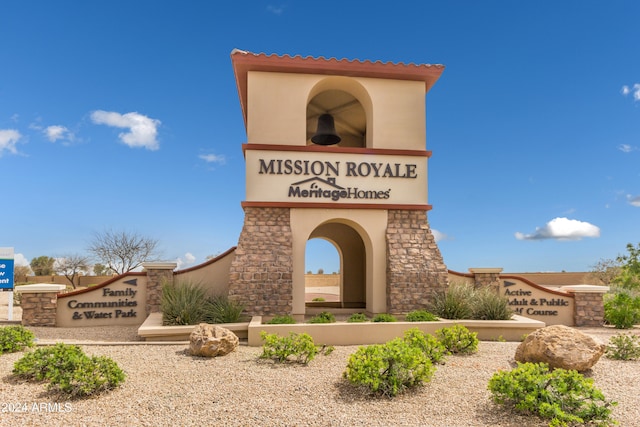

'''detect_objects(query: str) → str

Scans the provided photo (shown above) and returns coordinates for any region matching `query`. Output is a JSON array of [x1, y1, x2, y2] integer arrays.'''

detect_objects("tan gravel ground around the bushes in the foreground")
[[0, 294, 640, 427]]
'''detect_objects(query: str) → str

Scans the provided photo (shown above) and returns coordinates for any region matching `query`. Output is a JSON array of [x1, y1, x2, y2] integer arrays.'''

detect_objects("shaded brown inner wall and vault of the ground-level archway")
[[305, 222, 367, 310]]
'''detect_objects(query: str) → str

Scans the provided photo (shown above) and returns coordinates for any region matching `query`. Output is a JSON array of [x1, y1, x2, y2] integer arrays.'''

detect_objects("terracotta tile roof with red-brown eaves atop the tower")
[[231, 49, 444, 122]]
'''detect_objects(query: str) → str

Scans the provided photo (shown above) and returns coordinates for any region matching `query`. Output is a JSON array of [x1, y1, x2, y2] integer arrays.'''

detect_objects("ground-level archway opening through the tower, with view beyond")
[[305, 222, 366, 309]]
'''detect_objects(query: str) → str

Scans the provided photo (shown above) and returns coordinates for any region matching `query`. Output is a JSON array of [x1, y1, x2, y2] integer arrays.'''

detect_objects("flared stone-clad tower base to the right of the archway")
[[386, 210, 448, 313]]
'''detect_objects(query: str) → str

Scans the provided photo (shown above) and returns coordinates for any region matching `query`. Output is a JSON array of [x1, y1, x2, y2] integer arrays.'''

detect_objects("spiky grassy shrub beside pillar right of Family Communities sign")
[[160, 282, 207, 326]]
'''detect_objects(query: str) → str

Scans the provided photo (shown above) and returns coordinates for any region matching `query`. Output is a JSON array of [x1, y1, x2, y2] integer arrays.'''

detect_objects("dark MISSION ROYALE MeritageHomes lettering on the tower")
[[258, 158, 418, 202]]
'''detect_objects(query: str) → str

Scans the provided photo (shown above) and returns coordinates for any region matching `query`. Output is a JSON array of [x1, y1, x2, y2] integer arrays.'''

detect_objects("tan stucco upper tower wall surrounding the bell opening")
[[247, 71, 426, 150]]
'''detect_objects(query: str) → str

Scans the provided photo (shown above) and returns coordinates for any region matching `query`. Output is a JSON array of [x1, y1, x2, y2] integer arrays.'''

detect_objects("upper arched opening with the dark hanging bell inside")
[[307, 89, 367, 148]]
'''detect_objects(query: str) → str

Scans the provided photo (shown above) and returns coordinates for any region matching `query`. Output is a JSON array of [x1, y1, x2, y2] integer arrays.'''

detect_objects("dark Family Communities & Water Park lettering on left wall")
[[67, 288, 138, 320]]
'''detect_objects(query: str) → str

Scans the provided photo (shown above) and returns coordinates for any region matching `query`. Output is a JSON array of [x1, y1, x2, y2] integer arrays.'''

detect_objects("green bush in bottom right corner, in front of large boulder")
[[488, 363, 616, 426]]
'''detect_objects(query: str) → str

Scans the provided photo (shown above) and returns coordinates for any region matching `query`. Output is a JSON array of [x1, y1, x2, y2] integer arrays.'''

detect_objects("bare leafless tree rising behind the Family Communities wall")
[[88, 230, 158, 274]]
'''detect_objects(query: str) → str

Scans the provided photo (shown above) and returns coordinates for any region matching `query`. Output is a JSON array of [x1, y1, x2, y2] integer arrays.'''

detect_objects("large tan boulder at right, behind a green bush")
[[515, 325, 607, 372]]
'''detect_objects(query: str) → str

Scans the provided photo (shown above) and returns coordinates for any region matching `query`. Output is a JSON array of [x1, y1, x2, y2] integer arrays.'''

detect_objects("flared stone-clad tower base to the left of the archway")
[[229, 207, 293, 315]]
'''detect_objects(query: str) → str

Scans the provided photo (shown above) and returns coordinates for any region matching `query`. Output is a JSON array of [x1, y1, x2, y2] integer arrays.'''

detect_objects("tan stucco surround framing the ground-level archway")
[[291, 209, 387, 315]]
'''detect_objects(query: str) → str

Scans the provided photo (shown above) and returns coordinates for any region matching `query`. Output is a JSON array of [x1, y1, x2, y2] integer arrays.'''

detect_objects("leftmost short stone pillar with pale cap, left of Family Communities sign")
[[14, 283, 66, 326]]
